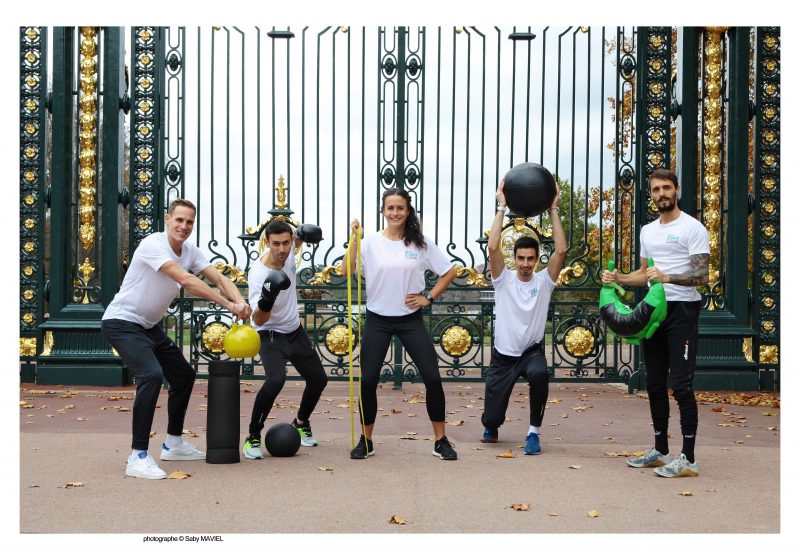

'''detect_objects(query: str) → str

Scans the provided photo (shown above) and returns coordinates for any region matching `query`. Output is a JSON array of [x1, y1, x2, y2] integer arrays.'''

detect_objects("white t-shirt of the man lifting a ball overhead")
[[492, 267, 556, 356]]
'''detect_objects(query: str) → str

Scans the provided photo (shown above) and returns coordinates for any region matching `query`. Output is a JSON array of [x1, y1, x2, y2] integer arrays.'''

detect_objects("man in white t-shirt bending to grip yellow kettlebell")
[[101, 199, 250, 479]]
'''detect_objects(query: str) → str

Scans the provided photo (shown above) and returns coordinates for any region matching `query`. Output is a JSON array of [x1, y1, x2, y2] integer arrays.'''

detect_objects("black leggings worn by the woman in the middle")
[[361, 310, 444, 426]]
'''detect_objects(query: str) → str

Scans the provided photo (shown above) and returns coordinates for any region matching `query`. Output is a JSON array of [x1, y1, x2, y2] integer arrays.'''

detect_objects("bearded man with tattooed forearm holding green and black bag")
[[602, 169, 710, 478]]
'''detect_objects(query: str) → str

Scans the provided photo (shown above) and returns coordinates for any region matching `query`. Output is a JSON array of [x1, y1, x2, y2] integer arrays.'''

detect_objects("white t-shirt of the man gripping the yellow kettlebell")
[[103, 231, 211, 329]]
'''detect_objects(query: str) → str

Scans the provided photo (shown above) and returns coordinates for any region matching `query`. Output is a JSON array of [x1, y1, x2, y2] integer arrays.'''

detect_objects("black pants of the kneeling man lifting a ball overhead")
[[481, 344, 550, 429]]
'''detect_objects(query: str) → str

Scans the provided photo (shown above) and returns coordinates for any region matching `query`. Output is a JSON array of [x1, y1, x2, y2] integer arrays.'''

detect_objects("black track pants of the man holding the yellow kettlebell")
[[101, 319, 195, 450]]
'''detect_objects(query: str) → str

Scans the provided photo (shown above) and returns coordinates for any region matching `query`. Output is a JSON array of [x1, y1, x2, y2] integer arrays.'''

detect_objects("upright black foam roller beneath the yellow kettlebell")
[[206, 360, 241, 464]]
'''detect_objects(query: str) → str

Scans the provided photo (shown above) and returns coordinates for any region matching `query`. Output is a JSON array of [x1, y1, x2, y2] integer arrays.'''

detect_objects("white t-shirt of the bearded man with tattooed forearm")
[[639, 212, 711, 301]]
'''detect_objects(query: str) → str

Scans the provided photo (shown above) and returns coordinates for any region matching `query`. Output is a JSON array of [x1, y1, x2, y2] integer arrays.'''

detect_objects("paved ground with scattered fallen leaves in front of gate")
[[19, 382, 781, 535]]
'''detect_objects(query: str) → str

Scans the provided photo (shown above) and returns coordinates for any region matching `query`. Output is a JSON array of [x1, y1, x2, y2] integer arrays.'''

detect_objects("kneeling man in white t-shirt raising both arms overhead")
[[481, 181, 567, 455]]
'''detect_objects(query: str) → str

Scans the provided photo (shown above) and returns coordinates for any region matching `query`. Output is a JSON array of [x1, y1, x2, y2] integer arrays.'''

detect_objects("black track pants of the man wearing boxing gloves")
[[249, 325, 328, 435]]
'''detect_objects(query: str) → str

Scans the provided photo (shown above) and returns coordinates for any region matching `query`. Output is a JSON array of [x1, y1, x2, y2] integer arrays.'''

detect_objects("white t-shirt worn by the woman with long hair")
[[361, 231, 453, 317]]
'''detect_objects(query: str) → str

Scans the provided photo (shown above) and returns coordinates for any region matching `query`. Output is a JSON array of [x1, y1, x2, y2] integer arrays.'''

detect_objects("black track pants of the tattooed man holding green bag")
[[642, 301, 700, 435]]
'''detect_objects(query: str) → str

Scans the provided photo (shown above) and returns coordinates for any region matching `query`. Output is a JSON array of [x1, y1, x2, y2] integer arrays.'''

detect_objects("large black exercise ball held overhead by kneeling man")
[[503, 163, 556, 217]]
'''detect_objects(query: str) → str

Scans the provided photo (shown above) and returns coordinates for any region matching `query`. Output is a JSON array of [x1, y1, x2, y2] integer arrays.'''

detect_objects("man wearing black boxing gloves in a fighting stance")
[[242, 220, 328, 459]]
